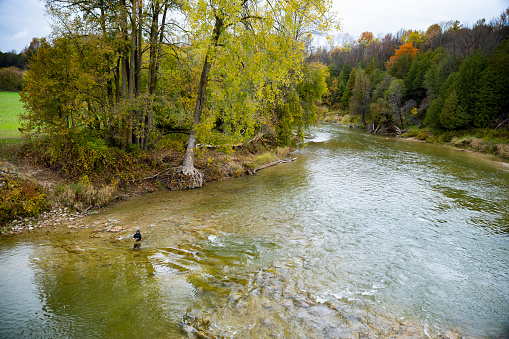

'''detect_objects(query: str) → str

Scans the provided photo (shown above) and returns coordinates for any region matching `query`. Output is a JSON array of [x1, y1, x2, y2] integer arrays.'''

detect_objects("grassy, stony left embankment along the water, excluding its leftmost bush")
[[0, 148, 295, 236]]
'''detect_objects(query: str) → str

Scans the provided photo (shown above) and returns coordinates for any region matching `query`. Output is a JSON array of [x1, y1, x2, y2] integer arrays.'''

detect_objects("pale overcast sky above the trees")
[[0, 0, 509, 53]]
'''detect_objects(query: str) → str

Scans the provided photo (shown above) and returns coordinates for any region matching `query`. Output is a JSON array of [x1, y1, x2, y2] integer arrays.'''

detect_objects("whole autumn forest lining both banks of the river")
[[0, 0, 509, 223]]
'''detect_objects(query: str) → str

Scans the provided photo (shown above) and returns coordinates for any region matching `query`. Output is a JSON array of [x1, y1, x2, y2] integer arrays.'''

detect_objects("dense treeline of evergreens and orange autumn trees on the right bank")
[[309, 8, 509, 132]]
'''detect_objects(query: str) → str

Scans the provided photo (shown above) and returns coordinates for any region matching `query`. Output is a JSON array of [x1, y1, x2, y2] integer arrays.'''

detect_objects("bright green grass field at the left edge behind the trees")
[[0, 92, 23, 139]]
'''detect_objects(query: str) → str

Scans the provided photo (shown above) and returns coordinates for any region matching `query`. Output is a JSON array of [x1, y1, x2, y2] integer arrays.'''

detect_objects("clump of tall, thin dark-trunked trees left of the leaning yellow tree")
[[46, 0, 176, 149]]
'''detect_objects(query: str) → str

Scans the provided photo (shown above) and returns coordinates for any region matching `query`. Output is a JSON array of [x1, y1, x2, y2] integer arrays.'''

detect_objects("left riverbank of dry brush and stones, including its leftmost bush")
[[0, 142, 295, 236]]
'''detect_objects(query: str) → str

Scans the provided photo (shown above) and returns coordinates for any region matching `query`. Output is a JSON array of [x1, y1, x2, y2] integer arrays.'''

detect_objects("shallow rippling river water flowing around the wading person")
[[0, 125, 509, 338]]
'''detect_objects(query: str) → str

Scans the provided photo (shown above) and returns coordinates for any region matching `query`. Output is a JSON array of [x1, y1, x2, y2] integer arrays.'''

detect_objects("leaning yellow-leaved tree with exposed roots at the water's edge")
[[178, 0, 336, 188]]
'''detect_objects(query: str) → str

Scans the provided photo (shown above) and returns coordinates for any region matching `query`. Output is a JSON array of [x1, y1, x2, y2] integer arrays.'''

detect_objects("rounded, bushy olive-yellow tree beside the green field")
[[21, 38, 97, 137]]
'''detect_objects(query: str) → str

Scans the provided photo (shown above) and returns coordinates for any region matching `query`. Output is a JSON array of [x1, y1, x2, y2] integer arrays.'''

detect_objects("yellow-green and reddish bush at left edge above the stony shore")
[[0, 173, 49, 225]]
